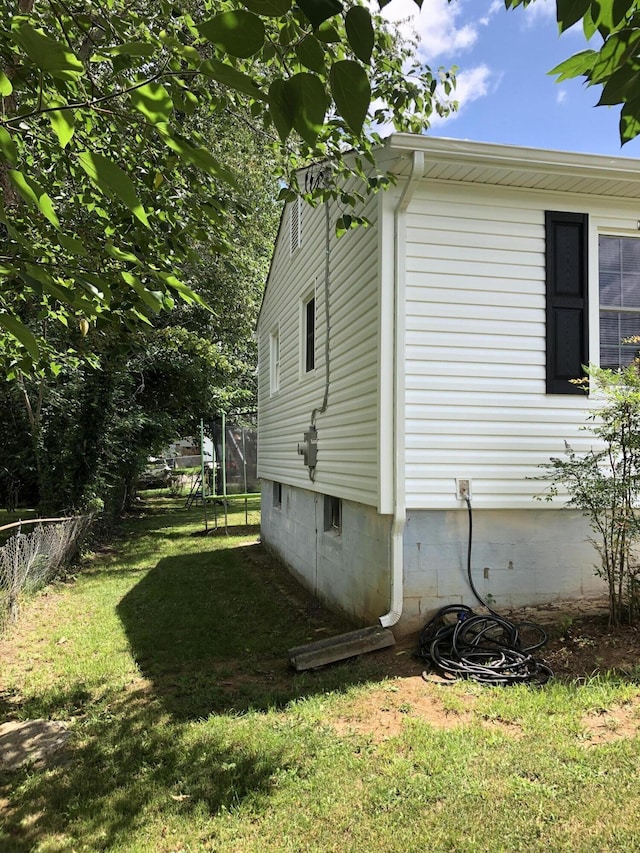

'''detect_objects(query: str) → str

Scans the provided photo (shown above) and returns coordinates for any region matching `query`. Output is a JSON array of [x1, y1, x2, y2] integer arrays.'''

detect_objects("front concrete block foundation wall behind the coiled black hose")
[[399, 509, 606, 633]]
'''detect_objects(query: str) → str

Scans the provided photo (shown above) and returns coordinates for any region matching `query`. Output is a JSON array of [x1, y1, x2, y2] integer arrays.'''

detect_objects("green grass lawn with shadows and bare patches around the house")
[[0, 496, 640, 853]]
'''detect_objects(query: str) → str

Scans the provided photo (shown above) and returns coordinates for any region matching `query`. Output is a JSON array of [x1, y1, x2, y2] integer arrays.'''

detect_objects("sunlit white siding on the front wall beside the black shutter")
[[405, 181, 637, 509]]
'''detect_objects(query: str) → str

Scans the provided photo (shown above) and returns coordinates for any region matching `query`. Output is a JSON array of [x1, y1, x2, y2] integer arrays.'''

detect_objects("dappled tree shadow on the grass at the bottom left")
[[0, 690, 296, 853]]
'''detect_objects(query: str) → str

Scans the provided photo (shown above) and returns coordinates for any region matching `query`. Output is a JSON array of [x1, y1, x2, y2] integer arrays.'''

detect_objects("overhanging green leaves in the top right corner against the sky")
[[505, 0, 640, 145]]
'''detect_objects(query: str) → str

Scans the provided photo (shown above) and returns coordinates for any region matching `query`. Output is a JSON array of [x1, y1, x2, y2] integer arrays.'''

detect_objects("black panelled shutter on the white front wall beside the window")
[[545, 211, 589, 394]]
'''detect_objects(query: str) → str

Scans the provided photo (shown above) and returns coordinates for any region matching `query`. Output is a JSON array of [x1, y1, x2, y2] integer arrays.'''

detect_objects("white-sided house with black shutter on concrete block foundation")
[[258, 134, 640, 633]]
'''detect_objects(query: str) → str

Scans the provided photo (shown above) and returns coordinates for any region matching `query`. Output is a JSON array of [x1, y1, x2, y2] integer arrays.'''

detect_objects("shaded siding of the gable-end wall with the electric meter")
[[258, 191, 379, 506]]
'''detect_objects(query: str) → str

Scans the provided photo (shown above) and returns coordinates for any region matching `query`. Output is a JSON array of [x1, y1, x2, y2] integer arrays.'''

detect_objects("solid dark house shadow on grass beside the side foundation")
[[118, 544, 420, 719]]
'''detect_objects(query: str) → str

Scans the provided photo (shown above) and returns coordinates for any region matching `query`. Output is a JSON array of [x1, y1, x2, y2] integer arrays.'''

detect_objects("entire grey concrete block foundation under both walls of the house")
[[262, 481, 606, 636]]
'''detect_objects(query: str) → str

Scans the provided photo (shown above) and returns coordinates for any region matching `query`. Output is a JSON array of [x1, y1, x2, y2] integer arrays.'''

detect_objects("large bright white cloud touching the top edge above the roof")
[[382, 0, 478, 62]]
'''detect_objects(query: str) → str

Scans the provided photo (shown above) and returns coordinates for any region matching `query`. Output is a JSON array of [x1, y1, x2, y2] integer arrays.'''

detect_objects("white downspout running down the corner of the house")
[[380, 151, 424, 628]]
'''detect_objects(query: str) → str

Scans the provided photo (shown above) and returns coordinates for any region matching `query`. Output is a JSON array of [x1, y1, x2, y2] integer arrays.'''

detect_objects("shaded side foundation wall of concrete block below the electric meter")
[[261, 480, 391, 625]]
